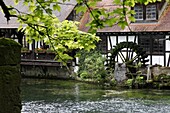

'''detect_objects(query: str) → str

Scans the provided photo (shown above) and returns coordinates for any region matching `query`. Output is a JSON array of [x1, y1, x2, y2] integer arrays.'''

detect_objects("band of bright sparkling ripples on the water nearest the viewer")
[[22, 98, 170, 113]]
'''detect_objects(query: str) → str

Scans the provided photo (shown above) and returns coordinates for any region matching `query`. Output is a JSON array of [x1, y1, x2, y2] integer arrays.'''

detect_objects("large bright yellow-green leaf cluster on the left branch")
[[0, 0, 100, 64]]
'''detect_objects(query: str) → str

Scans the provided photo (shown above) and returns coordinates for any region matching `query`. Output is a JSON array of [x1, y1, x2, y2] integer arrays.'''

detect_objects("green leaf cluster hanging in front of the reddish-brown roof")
[[77, 0, 161, 32]]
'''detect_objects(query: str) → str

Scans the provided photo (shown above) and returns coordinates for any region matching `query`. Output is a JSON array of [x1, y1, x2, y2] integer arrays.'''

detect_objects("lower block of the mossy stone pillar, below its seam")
[[0, 65, 21, 113]]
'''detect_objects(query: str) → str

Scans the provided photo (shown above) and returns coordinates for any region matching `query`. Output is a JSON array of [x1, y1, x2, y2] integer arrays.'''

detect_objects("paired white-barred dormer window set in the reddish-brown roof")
[[134, 4, 157, 21]]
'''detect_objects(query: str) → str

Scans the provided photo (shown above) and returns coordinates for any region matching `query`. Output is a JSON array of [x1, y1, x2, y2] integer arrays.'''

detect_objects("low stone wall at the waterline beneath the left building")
[[21, 65, 71, 79]]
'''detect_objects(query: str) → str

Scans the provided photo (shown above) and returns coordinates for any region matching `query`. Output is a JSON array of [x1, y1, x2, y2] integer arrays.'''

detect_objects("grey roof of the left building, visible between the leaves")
[[0, 0, 77, 28]]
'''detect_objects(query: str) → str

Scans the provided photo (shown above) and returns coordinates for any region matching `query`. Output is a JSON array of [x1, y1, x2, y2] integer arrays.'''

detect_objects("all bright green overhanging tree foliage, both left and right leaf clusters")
[[0, 0, 163, 63]]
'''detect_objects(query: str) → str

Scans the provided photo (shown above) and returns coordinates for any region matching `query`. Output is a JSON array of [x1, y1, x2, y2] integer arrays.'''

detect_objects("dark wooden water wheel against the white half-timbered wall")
[[108, 42, 149, 73]]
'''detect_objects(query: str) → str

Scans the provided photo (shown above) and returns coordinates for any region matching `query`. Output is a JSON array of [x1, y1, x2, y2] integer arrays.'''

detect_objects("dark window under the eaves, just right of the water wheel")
[[138, 35, 165, 55]]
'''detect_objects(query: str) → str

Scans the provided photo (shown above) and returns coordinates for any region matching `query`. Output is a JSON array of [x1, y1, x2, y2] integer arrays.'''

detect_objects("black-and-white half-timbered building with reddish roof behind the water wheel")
[[80, 0, 170, 66]]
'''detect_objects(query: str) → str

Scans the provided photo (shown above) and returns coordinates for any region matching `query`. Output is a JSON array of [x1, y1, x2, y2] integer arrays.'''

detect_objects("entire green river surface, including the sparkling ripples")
[[21, 79, 170, 113]]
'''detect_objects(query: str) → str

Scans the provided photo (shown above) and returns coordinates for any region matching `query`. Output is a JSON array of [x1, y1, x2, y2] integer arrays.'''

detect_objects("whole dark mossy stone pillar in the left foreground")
[[0, 38, 21, 113]]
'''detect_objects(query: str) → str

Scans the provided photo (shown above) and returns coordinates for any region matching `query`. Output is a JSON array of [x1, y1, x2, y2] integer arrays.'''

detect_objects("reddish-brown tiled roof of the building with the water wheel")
[[80, 0, 170, 32]]
